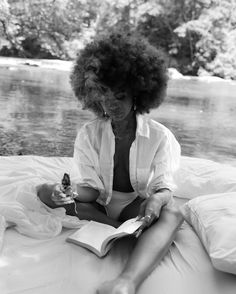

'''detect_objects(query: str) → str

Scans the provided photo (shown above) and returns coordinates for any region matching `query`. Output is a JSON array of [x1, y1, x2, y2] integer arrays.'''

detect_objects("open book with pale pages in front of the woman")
[[66, 218, 143, 257]]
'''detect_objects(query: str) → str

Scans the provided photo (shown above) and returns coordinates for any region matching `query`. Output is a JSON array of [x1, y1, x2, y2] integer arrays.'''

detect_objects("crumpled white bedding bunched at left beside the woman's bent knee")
[[0, 156, 85, 249]]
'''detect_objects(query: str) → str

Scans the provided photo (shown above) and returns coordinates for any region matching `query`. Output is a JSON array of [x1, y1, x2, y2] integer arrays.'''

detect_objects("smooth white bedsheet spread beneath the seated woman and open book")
[[0, 156, 236, 294]]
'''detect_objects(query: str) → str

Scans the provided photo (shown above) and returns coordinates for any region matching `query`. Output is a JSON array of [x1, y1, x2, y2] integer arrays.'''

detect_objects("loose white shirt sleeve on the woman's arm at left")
[[74, 127, 105, 194]]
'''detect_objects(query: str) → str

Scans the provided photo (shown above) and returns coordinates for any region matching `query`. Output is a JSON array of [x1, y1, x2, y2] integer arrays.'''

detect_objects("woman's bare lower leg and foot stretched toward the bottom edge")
[[97, 205, 183, 294]]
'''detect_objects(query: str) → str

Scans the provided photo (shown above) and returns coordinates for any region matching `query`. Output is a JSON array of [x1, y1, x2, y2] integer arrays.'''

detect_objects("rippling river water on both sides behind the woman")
[[0, 66, 236, 166]]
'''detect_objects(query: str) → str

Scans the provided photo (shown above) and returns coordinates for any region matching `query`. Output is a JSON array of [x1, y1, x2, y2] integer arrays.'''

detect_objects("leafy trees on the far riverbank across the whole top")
[[0, 0, 236, 79]]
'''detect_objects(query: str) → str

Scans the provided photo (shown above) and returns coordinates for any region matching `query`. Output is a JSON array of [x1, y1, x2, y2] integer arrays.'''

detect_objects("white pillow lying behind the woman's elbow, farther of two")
[[174, 156, 236, 199]]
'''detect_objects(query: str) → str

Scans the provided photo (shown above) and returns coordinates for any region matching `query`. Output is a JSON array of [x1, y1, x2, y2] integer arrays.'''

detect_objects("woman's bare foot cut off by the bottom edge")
[[97, 278, 135, 294]]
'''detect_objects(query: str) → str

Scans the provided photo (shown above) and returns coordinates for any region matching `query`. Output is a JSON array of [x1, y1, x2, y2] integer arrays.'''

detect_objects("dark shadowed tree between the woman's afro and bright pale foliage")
[[137, 0, 211, 74]]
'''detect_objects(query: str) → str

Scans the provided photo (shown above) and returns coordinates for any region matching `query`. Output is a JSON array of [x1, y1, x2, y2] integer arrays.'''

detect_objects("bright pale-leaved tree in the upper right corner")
[[172, 0, 236, 78]]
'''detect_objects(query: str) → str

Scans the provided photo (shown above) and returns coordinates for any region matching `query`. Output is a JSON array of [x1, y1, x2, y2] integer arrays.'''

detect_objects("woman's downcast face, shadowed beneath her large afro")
[[101, 91, 133, 121]]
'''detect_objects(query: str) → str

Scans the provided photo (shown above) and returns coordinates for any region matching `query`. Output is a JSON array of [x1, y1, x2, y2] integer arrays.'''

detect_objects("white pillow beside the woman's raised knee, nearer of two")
[[181, 192, 236, 274]]
